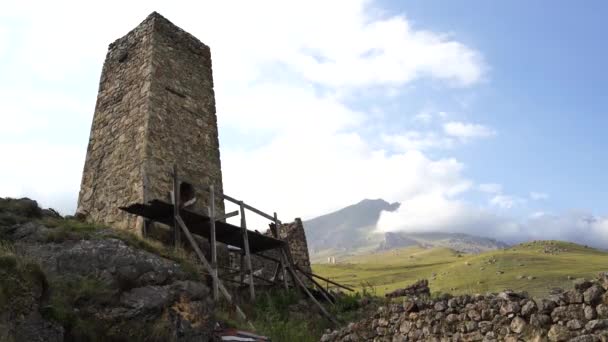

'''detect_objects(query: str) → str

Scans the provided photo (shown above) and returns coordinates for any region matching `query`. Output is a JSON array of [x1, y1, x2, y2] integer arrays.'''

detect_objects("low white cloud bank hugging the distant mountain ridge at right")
[[378, 200, 608, 248]]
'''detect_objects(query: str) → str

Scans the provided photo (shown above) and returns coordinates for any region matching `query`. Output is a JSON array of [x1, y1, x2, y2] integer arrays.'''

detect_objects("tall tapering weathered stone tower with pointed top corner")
[[78, 12, 224, 232]]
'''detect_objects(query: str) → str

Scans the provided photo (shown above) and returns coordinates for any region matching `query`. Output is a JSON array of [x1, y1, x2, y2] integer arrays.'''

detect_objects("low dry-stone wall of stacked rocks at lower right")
[[321, 273, 608, 342]]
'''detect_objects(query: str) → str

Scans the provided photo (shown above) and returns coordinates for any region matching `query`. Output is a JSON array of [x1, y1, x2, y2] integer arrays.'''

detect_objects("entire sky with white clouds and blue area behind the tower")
[[0, 0, 608, 247]]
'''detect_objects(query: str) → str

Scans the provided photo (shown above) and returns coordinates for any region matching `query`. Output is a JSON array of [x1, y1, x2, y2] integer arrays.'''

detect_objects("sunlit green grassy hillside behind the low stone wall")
[[313, 241, 608, 296]]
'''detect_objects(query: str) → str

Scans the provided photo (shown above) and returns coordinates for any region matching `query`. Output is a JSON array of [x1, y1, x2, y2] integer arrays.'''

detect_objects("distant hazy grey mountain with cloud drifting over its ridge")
[[304, 199, 507, 262]]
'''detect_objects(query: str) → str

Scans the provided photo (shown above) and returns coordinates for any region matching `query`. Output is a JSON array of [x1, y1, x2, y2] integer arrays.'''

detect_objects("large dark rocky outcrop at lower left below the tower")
[[0, 199, 214, 341]]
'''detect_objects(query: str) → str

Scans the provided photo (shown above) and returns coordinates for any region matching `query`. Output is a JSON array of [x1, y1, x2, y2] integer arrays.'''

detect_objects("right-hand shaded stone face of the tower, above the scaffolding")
[[145, 17, 224, 214]]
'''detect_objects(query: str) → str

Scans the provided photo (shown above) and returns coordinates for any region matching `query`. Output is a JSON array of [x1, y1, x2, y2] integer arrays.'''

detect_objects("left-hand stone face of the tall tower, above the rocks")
[[78, 18, 153, 228]]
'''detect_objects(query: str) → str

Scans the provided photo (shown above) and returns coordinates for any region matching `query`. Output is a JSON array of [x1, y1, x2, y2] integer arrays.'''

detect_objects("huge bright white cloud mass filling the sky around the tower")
[[0, 0, 608, 251]]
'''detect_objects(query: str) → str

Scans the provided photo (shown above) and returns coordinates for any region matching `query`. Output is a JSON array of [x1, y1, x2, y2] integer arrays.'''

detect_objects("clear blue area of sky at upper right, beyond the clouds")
[[383, 1, 608, 213]]
